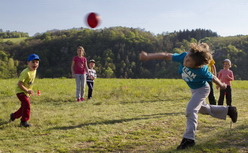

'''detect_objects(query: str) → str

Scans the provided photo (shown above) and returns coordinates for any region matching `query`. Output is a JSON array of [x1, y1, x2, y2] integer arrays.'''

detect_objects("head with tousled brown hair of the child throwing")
[[188, 43, 213, 66]]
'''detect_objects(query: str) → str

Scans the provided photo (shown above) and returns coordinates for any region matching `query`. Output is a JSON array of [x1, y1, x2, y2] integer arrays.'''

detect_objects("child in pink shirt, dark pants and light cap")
[[217, 59, 234, 106]]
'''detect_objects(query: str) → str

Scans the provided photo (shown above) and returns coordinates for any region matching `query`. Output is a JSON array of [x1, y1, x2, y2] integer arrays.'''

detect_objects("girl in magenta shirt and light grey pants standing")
[[71, 46, 88, 102]]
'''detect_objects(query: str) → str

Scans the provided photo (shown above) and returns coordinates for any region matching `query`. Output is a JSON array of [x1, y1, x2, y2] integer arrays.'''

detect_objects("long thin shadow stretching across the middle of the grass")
[[48, 112, 185, 130]]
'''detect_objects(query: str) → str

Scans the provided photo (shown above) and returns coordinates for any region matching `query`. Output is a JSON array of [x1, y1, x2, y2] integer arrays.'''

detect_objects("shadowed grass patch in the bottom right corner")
[[155, 124, 248, 153]]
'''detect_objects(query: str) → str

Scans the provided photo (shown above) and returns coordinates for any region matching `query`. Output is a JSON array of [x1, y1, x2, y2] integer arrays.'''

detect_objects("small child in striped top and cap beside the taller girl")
[[87, 59, 97, 99]]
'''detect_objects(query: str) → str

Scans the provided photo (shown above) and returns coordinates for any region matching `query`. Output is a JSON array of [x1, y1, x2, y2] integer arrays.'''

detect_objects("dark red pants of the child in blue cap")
[[14, 93, 30, 121]]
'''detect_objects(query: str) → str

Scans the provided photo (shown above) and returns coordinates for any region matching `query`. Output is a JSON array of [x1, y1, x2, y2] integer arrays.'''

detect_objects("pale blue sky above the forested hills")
[[0, 0, 248, 37]]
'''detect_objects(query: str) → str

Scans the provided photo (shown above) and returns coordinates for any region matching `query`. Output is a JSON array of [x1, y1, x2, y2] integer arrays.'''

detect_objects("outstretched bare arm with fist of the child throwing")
[[140, 51, 173, 61]]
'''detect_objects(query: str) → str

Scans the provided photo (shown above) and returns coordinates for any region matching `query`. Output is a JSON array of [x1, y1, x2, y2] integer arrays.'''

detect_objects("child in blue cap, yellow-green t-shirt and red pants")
[[10, 54, 40, 127]]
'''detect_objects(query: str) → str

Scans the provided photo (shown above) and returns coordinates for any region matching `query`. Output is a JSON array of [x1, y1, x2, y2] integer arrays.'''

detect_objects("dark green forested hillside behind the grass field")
[[0, 27, 248, 80]]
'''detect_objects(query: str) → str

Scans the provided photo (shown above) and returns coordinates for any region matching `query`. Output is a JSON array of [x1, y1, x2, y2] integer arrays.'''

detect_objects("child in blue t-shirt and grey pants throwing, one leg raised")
[[140, 43, 238, 150]]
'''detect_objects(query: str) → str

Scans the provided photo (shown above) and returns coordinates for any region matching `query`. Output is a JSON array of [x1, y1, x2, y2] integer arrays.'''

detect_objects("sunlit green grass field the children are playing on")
[[0, 78, 248, 153]]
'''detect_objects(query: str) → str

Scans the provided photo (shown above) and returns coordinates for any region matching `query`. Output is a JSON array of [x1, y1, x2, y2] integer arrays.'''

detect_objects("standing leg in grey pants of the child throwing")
[[183, 84, 210, 140]]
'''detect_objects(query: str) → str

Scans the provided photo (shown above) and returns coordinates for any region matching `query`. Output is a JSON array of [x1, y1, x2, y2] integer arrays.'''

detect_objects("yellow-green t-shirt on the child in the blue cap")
[[16, 68, 36, 96]]
